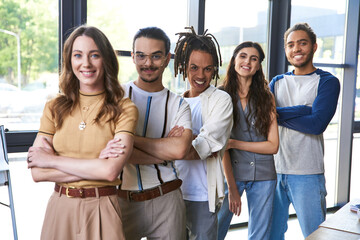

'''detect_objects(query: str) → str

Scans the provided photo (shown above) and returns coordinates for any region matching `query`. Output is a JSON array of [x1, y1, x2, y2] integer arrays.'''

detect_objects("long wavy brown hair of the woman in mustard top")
[[52, 25, 124, 129]]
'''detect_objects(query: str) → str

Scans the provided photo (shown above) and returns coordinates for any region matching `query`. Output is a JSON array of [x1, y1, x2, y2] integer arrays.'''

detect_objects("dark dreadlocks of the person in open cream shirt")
[[174, 26, 222, 86]]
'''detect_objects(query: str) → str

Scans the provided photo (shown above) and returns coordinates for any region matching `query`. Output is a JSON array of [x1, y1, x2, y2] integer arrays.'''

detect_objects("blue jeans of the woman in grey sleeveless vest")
[[218, 180, 276, 240]]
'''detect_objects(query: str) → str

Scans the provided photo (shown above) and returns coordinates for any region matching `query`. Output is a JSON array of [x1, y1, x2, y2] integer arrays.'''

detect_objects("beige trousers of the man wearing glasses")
[[119, 189, 186, 240]]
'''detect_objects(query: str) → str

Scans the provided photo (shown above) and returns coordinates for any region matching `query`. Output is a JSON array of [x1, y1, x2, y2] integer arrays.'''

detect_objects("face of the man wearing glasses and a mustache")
[[132, 37, 170, 84]]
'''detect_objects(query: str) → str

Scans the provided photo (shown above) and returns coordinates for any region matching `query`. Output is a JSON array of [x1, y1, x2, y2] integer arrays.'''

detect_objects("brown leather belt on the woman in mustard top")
[[54, 184, 118, 198]]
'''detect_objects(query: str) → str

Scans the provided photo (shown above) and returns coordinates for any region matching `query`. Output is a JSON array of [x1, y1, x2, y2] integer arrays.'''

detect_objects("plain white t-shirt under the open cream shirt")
[[175, 97, 208, 202]]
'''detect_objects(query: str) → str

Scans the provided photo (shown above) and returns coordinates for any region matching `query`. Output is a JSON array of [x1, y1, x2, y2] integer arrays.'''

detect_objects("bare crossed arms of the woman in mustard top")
[[28, 133, 134, 182]]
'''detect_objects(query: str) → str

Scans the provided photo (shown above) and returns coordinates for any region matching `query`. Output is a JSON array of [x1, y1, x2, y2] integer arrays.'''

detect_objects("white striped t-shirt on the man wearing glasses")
[[121, 82, 191, 190]]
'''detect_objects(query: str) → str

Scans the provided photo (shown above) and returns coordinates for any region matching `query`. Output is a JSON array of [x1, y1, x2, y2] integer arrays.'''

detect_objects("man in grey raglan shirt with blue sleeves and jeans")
[[270, 23, 340, 240]]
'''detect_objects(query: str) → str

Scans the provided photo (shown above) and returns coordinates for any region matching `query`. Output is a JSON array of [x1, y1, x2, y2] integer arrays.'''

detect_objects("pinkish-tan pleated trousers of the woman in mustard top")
[[41, 192, 125, 240]]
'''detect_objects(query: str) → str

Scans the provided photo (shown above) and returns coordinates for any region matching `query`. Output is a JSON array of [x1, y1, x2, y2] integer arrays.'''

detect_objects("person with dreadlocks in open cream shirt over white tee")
[[174, 27, 233, 240]]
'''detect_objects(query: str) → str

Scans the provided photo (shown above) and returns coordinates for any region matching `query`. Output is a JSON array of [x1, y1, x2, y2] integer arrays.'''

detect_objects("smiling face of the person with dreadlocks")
[[187, 50, 214, 97]]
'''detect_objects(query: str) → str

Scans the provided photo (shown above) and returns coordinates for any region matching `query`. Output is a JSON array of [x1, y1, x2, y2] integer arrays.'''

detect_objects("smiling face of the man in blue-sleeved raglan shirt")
[[285, 30, 317, 71]]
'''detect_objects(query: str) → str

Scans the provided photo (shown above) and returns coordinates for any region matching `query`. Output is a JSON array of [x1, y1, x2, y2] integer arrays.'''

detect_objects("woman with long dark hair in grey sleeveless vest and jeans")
[[218, 42, 279, 240]]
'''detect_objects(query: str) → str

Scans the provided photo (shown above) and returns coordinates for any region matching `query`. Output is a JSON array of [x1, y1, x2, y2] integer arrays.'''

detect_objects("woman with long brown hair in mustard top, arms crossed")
[[28, 26, 138, 240]]
